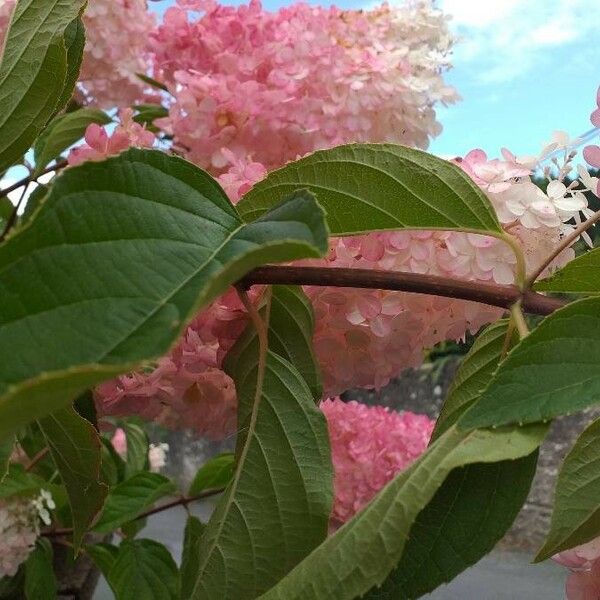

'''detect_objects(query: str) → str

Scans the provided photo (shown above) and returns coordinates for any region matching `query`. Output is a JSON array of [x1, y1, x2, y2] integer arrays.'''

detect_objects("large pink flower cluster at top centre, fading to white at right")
[[151, 0, 457, 190]]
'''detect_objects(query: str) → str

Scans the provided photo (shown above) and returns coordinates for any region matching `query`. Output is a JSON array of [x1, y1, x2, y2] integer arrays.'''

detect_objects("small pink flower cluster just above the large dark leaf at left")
[[68, 108, 156, 166]]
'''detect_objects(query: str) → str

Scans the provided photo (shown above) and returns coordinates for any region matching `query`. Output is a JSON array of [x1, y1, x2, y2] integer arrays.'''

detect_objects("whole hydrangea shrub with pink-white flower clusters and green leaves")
[[0, 0, 600, 600]]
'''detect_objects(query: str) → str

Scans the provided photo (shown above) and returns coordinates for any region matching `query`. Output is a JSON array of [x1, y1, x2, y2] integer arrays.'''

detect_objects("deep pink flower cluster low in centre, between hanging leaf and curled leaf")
[[321, 398, 434, 528]]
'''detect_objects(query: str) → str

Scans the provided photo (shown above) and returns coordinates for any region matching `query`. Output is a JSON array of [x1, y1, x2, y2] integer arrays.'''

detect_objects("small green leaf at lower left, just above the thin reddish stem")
[[94, 472, 177, 533]]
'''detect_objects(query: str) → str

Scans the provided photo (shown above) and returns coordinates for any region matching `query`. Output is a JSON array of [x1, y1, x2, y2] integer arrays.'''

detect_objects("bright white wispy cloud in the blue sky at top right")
[[438, 0, 598, 83]]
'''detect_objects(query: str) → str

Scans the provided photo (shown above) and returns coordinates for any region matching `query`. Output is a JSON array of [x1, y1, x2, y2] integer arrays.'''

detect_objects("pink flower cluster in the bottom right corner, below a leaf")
[[552, 538, 600, 600]]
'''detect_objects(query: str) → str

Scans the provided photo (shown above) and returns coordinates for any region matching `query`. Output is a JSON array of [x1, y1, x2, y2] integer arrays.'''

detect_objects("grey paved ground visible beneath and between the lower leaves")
[[94, 494, 565, 600]]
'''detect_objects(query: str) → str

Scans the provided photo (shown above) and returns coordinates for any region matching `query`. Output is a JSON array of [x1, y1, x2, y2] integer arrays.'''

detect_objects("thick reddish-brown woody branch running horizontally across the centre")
[[238, 265, 565, 315]]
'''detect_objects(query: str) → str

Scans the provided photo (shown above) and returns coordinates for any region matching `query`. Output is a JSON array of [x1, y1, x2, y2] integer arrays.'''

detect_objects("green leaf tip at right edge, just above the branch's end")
[[534, 248, 600, 294]]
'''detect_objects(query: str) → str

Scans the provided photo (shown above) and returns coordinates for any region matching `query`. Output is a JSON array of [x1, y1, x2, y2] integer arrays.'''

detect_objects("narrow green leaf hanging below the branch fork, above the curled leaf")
[[431, 319, 518, 440]]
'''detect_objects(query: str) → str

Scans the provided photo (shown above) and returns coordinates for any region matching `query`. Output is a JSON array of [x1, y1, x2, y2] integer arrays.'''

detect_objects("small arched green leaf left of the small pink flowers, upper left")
[[33, 108, 111, 176]]
